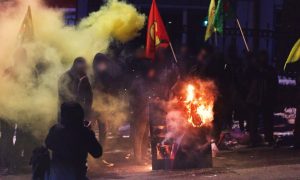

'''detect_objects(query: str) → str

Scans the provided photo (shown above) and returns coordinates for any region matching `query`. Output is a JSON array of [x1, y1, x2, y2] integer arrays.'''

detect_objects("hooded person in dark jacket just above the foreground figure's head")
[[58, 57, 93, 117]]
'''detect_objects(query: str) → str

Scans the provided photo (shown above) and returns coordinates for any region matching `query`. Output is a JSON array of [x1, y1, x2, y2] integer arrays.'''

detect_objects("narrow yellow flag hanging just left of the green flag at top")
[[205, 0, 216, 41]]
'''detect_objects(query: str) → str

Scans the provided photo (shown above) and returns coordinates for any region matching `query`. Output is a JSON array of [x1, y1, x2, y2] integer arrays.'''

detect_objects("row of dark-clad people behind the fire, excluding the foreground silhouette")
[[55, 42, 278, 162]]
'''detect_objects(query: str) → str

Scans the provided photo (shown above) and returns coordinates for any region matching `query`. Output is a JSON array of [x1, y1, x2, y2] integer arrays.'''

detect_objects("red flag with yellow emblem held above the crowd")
[[146, 0, 170, 60]]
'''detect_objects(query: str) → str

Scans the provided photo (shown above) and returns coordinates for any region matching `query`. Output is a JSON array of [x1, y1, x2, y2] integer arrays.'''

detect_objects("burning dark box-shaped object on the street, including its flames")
[[150, 80, 216, 170]]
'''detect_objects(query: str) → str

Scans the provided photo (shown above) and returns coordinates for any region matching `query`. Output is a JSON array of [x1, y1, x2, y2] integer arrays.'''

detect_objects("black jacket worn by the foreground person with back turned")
[[45, 124, 102, 177]]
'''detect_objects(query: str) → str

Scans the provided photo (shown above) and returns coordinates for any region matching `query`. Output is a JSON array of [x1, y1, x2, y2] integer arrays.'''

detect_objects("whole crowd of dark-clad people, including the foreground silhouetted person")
[[0, 42, 298, 179]]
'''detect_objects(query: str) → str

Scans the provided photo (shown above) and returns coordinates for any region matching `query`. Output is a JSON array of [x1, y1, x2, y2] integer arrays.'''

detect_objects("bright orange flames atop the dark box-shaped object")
[[184, 82, 214, 127]]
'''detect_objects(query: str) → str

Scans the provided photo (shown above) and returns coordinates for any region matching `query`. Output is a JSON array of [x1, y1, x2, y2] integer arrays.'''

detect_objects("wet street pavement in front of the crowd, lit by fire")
[[0, 143, 300, 180]]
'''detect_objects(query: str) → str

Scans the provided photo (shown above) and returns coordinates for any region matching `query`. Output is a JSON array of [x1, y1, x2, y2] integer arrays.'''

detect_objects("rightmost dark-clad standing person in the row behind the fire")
[[247, 51, 278, 146]]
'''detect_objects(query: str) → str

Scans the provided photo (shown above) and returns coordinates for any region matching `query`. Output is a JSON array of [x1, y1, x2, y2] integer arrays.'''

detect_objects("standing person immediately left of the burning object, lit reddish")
[[129, 60, 156, 163]]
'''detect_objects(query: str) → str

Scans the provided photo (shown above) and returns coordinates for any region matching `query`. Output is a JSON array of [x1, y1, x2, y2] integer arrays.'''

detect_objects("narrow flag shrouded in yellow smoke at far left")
[[18, 6, 34, 43]]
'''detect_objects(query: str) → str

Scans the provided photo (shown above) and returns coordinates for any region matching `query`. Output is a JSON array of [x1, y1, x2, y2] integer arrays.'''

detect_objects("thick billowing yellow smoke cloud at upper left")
[[0, 0, 145, 137]]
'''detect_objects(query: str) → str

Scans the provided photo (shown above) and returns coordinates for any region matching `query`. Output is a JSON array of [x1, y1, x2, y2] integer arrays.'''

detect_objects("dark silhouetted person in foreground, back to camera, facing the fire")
[[45, 102, 102, 180]]
